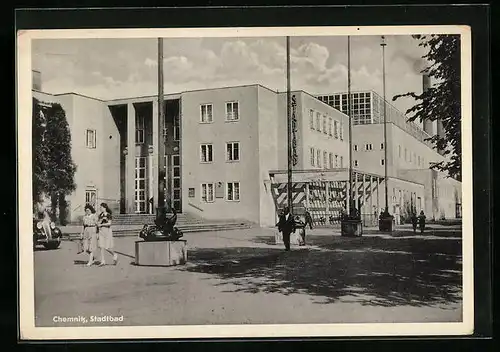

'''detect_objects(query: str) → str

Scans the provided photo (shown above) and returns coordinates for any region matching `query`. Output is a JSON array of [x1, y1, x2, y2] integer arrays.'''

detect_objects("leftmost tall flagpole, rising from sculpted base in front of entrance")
[[157, 38, 166, 209]]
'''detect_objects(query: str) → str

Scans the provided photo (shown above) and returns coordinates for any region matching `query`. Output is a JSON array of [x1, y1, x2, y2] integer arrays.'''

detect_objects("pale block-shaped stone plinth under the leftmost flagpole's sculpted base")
[[135, 240, 187, 266]]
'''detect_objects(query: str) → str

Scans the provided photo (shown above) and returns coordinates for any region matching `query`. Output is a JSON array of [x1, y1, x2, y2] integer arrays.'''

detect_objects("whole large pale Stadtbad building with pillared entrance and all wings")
[[33, 73, 457, 226]]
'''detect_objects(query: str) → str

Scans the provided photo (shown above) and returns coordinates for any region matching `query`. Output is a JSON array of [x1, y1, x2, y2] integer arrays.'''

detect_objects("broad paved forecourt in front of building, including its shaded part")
[[35, 226, 462, 326]]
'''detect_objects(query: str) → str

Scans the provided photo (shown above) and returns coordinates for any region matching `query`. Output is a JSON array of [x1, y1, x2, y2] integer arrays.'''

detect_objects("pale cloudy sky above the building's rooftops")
[[32, 36, 426, 112]]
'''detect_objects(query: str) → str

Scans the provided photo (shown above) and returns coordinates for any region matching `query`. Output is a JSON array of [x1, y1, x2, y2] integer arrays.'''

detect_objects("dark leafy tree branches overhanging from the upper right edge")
[[393, 35, 462, 180]]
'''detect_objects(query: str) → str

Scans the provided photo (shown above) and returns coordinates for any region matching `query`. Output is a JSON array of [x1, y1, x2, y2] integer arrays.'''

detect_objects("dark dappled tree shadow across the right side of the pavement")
[[183, 235, 462, 307]]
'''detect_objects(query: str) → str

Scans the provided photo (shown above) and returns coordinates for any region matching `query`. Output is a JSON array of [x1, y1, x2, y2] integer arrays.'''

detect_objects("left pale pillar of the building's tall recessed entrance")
[[125, 103, 135, 214]]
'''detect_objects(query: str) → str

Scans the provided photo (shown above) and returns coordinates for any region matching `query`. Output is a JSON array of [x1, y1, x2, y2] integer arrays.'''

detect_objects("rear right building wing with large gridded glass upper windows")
[[317, 80, 462, 223]]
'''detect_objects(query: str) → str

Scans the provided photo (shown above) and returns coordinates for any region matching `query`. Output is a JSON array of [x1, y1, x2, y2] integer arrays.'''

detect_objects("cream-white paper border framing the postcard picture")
[[16, 26, 474, 340]]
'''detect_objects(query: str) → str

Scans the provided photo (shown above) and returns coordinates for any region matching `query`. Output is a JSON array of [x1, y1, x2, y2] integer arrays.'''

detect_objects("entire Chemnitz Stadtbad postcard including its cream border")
[[17, 26, 474, 339]]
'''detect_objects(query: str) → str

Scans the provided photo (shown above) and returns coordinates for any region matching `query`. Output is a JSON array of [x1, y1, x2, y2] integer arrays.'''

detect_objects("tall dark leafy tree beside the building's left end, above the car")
[[33, 99, 76, 223]]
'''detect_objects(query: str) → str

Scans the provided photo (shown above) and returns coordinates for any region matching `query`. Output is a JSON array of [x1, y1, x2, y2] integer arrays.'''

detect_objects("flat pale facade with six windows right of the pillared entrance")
[[181, 86, 260, 222]]
